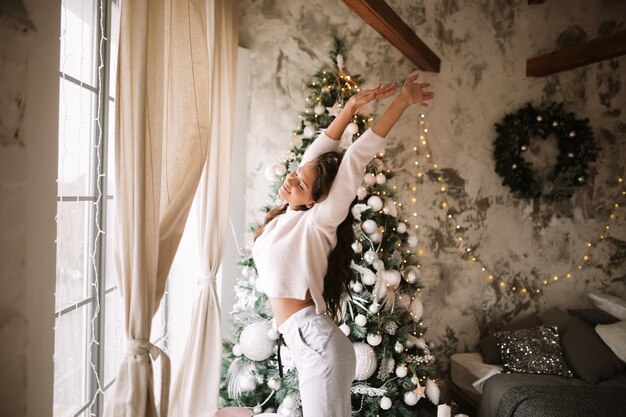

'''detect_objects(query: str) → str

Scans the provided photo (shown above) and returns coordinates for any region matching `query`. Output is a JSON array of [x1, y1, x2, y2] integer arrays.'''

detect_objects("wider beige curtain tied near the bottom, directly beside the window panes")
[[105, 0, 228, 417]]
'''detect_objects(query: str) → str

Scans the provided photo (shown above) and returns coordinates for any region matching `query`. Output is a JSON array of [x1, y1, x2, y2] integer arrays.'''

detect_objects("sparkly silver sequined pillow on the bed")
[[494, 326, 574, 378]]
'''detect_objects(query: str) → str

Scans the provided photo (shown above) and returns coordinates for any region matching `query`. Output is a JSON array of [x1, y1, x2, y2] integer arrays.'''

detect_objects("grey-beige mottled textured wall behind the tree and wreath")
[[240, 0, 626, 365]]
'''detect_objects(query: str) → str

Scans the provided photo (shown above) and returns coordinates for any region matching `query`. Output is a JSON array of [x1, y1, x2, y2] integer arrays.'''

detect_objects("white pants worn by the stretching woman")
[[278, 306, 356, 417]]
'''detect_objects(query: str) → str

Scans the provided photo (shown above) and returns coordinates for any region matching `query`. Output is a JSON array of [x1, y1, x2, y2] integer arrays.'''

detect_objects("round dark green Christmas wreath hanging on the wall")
[[493, 103, 599, 200]]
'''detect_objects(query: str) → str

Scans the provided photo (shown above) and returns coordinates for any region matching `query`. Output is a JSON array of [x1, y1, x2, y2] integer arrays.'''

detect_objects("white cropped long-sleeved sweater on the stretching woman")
[[252, 129, 384, 313]]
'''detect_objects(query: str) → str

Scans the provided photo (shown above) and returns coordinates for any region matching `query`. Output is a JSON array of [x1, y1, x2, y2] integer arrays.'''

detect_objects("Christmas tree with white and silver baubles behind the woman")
[[220, 37, 439, 417]]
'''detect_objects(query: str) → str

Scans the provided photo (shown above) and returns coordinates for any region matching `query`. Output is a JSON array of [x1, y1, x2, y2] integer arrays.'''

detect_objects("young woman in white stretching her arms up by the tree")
[[252, 74, 433, 417]]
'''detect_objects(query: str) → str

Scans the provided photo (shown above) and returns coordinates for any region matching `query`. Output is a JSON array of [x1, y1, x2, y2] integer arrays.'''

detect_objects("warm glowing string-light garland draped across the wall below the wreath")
[[410, 114, 626, 296]]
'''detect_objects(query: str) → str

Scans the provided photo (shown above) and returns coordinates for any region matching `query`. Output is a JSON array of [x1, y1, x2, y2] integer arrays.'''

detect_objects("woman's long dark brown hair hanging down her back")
[[254, 152, 354, 320]]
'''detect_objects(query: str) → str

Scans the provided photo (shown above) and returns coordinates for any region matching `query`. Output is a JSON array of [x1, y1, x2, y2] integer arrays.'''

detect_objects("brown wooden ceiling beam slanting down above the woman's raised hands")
[[342, 0, 441, 72]]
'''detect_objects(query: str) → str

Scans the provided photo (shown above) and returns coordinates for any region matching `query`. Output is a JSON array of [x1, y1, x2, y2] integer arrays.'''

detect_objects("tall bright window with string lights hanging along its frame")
[[54, 0, 168, 417]]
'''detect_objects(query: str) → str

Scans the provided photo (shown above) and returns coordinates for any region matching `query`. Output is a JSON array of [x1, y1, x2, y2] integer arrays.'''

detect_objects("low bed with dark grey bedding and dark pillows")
[[450, 300, 626, 417]]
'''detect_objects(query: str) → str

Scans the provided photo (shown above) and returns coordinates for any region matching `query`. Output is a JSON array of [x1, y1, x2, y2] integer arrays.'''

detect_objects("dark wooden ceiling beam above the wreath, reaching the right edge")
[[526, 30, 626, 77]]
